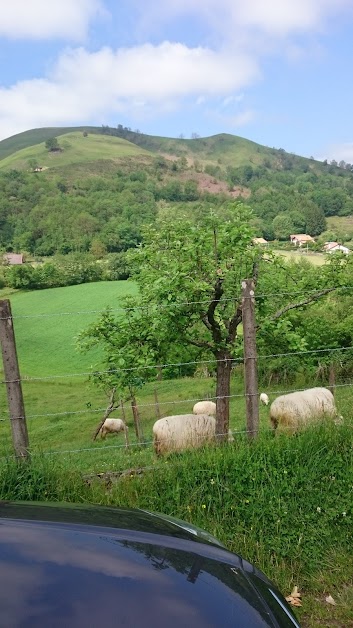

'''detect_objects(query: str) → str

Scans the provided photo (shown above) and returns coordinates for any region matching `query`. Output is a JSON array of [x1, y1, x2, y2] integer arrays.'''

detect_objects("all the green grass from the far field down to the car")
[[0, 282, 353, 627]]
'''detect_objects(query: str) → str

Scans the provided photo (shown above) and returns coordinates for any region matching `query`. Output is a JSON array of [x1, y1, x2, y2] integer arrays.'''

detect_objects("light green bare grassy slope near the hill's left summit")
[[0, 132, 148, 169]]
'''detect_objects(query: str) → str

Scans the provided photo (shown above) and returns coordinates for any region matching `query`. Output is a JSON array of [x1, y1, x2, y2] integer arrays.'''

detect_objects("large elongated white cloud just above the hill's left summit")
[[0, 42, 258, 138]]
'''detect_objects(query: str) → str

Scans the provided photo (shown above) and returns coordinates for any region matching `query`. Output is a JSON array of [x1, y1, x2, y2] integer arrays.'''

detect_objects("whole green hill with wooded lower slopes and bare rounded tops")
[[0, 125, 353, 256]]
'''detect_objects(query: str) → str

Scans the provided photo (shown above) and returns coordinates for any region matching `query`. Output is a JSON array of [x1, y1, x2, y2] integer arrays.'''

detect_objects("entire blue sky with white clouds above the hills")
[[0, 0, 353, 162]]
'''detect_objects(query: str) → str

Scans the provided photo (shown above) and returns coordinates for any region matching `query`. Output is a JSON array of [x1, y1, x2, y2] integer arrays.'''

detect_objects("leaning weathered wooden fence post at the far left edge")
[[0, 299, 29, 459]]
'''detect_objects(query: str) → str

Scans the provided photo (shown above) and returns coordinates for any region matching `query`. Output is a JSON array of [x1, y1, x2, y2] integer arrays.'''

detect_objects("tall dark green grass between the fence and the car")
[[0, 424, 353, 626]]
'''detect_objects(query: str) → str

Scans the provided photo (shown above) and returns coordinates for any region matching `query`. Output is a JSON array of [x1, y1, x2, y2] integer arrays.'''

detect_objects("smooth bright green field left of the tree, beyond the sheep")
[[2, 281, 136, 376]]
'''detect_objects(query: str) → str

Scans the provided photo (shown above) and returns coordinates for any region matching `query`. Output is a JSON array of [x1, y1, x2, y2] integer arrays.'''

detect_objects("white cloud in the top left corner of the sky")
[[0, 0, 105, 41]]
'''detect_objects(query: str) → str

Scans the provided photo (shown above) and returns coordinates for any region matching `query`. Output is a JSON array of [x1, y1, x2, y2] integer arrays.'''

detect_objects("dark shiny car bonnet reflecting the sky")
[[0, 501, 299, 628]]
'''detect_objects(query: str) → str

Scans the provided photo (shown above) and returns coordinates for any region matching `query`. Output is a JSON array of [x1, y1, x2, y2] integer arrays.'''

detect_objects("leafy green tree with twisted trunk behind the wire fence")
[[77, 203, 346, 440]]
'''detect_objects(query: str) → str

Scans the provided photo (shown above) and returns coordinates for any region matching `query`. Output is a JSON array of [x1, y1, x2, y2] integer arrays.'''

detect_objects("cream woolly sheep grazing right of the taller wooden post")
[[260, 388, 342, 431]]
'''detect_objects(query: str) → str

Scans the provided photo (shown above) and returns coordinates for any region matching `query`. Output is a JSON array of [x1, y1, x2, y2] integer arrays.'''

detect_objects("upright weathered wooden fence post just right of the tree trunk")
[[242, 279, 259, 438]]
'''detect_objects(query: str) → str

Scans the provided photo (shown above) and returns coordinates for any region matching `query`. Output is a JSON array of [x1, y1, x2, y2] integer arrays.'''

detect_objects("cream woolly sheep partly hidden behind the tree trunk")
[[152, 414, 234, 456]]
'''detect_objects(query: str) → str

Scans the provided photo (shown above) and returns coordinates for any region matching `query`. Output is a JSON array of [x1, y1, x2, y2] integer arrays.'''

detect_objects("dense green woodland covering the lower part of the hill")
[[0, 127, 353, 257]]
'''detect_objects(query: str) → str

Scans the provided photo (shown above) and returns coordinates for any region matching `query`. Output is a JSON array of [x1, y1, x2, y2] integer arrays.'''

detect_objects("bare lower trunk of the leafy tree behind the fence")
[[216, 351, 231, 442]]
